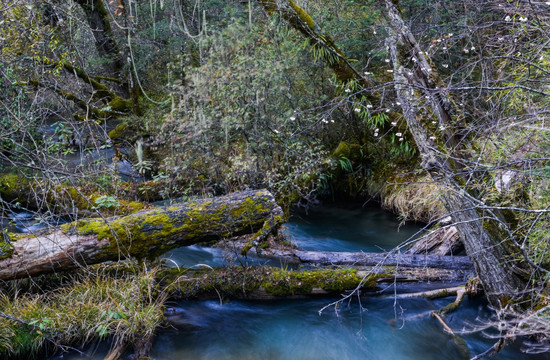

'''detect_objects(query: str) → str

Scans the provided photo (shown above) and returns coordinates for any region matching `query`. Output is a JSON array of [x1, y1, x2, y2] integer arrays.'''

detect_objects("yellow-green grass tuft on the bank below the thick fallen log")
[[0, 262, 164, 358]]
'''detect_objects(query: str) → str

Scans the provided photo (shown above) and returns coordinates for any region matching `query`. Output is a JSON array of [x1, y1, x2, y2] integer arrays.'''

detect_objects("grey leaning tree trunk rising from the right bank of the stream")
[[385, 0, 525, 307]]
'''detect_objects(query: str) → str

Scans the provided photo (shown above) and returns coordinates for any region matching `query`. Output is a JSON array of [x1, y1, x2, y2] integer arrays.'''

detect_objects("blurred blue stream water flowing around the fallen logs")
[[56, 206, 549, 360]]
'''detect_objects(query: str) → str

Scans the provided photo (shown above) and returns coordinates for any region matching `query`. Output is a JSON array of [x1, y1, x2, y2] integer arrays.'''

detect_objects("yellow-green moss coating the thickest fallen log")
[[63, 192, 282, 259]]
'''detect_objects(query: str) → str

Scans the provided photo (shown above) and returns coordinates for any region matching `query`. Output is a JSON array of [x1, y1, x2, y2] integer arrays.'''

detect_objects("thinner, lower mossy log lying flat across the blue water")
[[159, 266, 472, 300]]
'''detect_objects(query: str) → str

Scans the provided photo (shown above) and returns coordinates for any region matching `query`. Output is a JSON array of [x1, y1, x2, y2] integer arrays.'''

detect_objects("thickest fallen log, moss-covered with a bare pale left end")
[[0, 190, 283, 280]]
